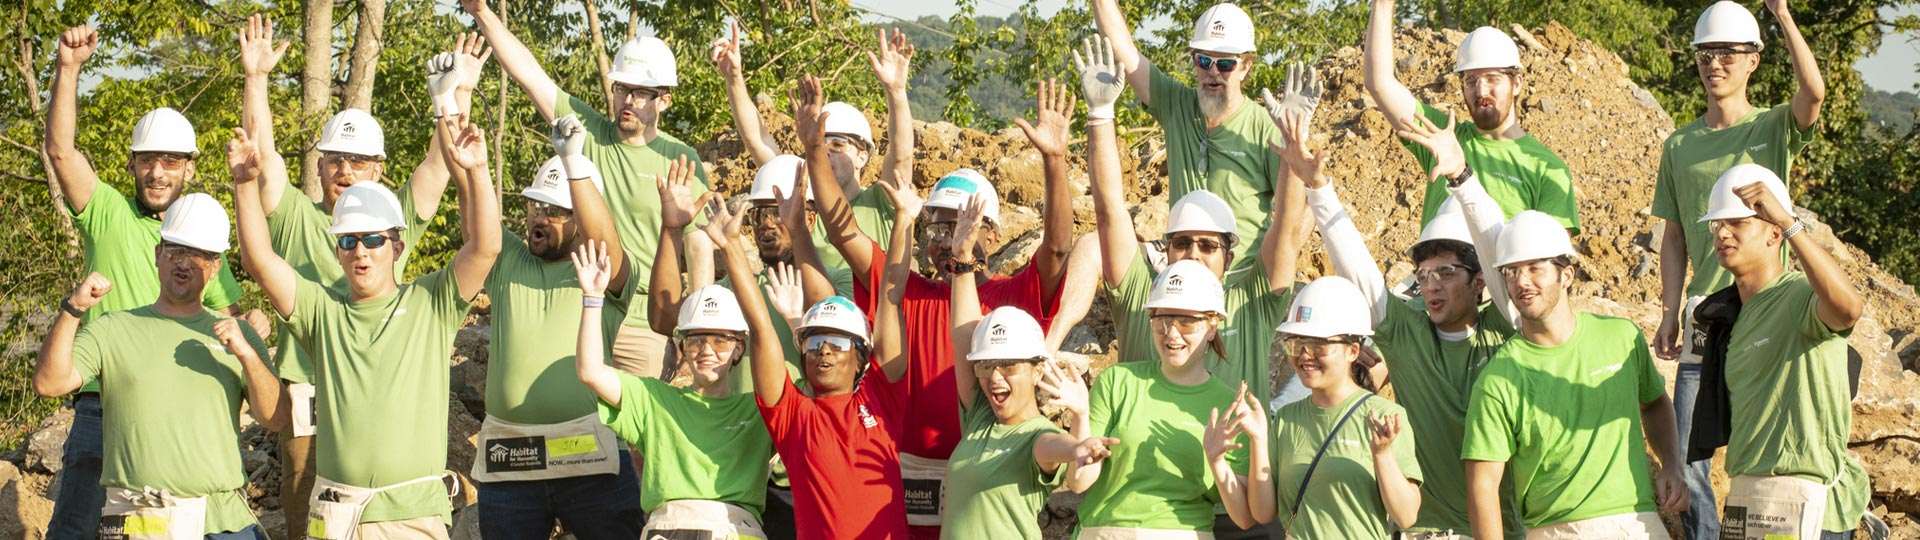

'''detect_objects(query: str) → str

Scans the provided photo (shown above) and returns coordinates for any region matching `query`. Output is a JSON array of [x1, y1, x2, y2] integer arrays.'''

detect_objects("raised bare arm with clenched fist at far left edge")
[[40, 27, 100, 213]]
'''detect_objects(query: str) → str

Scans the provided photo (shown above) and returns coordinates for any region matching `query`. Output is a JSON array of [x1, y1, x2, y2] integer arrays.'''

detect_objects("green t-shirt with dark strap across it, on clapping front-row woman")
[[1269, 390, 1428, 538]]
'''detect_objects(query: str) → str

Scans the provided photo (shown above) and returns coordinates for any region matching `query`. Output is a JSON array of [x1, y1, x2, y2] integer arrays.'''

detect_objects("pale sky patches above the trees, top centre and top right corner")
[[852, 0, 1920, 92]]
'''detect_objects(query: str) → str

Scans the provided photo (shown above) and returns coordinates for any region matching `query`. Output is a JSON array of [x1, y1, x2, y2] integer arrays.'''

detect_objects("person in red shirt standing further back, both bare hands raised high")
[[793, 77, 1098, 538]]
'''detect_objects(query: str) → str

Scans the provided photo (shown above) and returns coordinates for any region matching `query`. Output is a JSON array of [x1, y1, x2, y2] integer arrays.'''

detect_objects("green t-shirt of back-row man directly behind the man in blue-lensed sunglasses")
[[267, 183, 430, 382]]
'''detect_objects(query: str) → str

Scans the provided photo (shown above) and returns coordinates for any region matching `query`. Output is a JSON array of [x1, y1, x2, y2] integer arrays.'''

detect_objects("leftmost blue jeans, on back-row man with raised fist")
[[46, 392, 108, 540]]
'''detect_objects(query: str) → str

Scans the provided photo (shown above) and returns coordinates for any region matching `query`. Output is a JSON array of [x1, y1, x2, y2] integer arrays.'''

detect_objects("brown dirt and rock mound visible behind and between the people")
[[0, 25, 1920, 538]]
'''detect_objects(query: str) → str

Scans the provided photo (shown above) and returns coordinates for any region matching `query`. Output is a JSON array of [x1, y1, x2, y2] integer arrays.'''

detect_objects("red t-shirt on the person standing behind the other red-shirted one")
[[852, 242, 1064, 459]]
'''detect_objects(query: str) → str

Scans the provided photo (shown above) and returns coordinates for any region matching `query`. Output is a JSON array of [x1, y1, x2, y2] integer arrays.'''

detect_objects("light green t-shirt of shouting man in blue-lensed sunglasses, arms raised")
[[286, 267, 468, 523]]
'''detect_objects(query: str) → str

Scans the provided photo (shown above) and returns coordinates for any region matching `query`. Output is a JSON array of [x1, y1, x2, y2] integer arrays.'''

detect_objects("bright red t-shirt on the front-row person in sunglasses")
[[756, 359, 906, 540]]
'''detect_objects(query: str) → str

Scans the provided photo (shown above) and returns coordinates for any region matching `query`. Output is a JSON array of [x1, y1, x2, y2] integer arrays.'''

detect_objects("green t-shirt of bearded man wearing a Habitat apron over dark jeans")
[[486, 231, 626, 425]]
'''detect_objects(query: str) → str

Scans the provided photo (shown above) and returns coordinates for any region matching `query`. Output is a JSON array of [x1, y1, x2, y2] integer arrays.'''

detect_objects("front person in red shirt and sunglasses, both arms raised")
[[725, 172, 920, 540]]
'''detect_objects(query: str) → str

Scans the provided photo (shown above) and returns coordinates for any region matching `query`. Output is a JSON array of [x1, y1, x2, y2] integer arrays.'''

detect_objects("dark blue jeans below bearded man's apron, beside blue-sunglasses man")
[[480, 450, 647, 540]]
